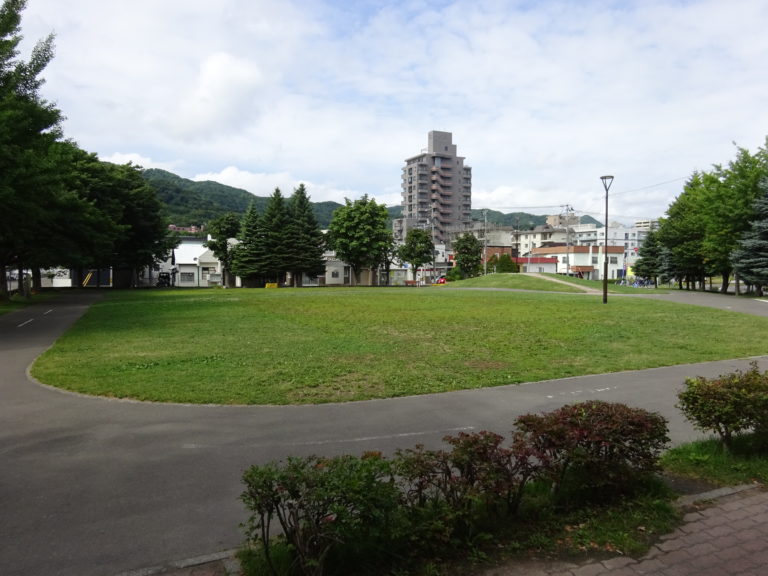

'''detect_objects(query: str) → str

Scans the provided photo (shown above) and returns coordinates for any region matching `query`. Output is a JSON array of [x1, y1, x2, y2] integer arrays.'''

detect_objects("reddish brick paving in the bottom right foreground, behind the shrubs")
[[146, 486, 768, 576]]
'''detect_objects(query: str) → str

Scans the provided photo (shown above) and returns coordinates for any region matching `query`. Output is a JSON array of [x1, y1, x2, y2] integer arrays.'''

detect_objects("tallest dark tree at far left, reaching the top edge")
[[0, 0, 62, 299]]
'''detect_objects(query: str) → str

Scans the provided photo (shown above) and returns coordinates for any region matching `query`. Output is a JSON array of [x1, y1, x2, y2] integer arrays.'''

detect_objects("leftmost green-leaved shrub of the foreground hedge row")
[[241, 455, 402, 576]]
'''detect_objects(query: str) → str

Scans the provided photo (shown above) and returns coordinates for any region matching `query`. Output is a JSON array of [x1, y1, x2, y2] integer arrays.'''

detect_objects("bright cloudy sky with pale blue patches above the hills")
[[16, 0, 768, 222]]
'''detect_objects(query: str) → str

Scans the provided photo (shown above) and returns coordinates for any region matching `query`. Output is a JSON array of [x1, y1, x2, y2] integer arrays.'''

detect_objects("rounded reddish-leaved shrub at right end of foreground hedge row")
[[515, 401, 669, 499]]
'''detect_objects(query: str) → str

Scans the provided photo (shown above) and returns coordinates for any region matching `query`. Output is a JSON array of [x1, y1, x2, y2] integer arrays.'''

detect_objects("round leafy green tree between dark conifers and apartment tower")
[[330, 194, 390, 284]]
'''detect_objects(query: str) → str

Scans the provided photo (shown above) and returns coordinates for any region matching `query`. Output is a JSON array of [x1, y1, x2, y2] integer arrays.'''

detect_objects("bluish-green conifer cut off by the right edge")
[[731, 179, 768, 296]]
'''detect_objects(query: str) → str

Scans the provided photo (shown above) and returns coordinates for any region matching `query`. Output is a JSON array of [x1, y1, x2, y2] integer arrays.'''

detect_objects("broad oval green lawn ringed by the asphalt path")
[[33, 288, 768, 404]]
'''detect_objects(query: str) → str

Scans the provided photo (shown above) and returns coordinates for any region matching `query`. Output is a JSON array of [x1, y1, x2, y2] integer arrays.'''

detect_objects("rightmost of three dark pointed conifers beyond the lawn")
[[286, 184, 325, 287]]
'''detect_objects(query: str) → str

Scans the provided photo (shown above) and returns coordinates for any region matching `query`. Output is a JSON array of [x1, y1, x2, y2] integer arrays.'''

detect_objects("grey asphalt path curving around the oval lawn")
[[0, 292, 768, 576]]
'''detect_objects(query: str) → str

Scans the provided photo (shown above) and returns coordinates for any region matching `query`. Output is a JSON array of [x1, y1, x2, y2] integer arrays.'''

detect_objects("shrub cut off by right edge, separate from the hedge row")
[[677, 362, 768, 448]]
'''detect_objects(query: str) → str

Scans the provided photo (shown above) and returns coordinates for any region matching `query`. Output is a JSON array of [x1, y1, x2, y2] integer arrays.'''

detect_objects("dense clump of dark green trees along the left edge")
[[0, 0, 173, 298]]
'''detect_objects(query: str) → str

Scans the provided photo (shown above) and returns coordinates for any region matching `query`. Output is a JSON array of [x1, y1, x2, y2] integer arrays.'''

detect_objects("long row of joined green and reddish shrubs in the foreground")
[[241, 402, 668, 576]]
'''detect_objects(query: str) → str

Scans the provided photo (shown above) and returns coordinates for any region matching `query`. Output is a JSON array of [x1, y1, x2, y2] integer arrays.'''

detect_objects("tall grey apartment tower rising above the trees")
[[393, 130, 472, 244]]
